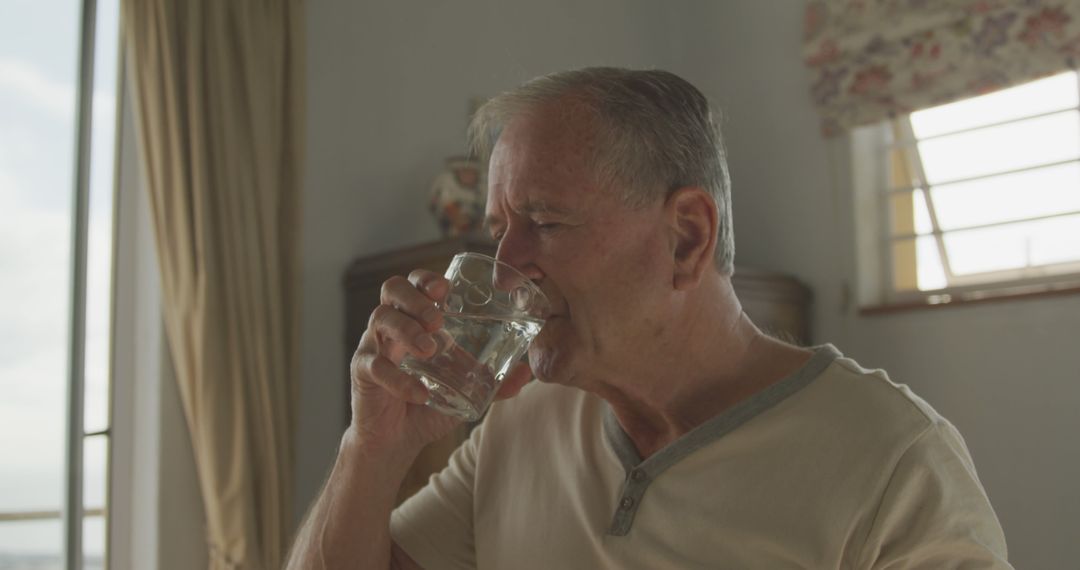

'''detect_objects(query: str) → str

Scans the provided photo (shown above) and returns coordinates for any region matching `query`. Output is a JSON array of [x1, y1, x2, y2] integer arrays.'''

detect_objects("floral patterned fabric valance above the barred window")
[[804, 0, 1080, 136]]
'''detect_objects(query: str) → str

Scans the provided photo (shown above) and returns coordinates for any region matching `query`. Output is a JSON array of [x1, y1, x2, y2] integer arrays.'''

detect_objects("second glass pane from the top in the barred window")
[[918, 111, 1080, 185]]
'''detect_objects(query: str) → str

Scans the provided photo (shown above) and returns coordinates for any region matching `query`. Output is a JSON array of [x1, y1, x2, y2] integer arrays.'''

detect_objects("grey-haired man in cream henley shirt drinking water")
[[291, 68, 1009, 570]]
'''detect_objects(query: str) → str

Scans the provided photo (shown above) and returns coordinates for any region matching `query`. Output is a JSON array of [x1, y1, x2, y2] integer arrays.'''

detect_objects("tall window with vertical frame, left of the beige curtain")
[[0, 0, 119, 570]]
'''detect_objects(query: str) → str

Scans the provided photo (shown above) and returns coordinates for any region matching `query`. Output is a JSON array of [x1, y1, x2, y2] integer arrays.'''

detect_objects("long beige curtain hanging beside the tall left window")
[[122, 0, 305, 569]]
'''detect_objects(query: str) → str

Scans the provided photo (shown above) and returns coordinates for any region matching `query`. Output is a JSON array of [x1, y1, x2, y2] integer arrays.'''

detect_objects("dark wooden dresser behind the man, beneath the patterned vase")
[[342, 238, 811, 502]]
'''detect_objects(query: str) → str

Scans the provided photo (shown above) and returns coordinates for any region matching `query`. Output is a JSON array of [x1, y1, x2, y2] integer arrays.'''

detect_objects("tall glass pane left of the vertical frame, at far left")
[[0, 0, 80, 524]]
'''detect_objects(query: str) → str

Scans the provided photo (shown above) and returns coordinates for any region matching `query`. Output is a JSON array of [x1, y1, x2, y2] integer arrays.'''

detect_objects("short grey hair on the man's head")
[[469, 67, 734, 274]]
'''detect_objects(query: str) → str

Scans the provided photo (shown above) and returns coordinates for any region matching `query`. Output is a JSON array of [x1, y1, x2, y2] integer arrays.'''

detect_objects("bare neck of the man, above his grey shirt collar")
[[594, 279, 811, 458]]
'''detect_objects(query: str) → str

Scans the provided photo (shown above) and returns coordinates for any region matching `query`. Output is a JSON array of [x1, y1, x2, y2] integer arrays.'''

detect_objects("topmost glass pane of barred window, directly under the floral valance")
[[912, 71, 1080, 138]]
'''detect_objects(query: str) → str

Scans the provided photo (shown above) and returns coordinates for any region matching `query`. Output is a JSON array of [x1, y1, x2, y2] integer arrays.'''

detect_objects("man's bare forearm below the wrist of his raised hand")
[[286, 430, 416, 570]]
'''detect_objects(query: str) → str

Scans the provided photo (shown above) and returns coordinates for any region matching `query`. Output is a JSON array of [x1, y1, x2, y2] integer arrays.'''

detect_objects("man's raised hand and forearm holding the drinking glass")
[[286, 271, 531, 570]]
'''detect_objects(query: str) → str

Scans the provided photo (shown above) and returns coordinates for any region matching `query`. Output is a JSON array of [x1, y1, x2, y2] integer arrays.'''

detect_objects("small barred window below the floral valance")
[[854, 71, 1080, 304]]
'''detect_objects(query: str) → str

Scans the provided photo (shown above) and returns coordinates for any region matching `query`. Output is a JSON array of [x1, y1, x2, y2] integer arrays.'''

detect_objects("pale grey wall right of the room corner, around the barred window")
[[672, 0, 1080, 568]]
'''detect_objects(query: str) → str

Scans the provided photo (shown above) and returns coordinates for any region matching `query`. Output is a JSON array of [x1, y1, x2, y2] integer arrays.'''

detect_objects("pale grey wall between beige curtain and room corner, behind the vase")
[[296, 0, 667, 516]]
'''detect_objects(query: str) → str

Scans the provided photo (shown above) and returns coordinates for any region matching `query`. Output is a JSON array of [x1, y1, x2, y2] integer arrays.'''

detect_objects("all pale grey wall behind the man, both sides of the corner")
[[296, 0, 1080, 568]]
